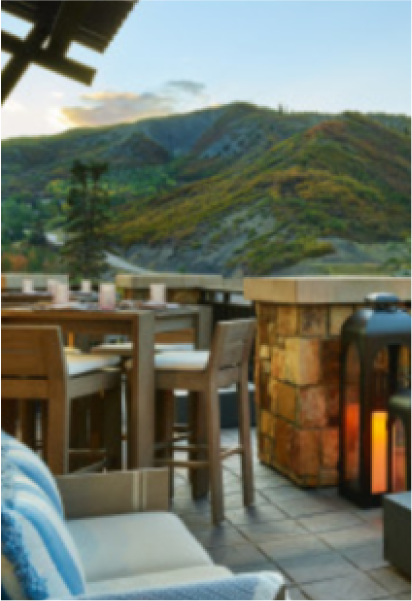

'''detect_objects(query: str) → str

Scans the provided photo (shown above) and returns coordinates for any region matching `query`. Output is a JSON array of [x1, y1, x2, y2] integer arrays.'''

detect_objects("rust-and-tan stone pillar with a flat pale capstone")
[[245, 278, 412, 487]]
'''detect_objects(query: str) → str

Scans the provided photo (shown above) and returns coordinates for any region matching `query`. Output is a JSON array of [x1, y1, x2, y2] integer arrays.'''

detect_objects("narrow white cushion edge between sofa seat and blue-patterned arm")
[[87, 566, 233, 595]]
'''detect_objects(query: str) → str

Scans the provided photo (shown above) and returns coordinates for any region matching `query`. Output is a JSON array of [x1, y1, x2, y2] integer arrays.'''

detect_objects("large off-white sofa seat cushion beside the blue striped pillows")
[[68, 513, 213, 583]]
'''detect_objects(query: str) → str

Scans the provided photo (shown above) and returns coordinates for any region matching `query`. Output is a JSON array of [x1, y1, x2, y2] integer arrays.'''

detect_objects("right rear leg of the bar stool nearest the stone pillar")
[[237, 374, 255, 507]]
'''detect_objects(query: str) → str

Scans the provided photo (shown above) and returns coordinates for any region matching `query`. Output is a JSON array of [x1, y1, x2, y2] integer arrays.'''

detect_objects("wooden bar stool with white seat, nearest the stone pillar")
[[155, 319, 256, 524]]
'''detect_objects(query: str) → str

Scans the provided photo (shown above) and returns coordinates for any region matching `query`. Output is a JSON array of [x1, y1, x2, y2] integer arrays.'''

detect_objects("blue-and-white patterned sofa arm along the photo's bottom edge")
[[65, 573, 290, 601]]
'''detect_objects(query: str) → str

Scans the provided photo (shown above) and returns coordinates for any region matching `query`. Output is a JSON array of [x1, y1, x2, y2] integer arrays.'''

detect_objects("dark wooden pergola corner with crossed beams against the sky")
[[1, 0, 139, 104]]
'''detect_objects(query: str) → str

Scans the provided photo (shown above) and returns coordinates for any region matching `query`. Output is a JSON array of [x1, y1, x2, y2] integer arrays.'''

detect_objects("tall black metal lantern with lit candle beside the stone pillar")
[[339, 293, 412, 508]]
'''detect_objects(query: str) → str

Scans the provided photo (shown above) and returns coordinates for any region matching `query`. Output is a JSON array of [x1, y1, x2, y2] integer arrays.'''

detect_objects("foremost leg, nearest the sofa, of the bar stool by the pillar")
[[206, 386, 225, 526]]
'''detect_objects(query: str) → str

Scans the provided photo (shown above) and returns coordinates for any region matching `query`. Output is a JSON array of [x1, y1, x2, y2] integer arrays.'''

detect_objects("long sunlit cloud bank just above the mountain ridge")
[[60, 80, 207, 127]]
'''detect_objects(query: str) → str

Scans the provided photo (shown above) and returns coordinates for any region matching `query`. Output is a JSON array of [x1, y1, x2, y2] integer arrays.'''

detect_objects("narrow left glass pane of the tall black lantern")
[[345, 344, 361, 489]]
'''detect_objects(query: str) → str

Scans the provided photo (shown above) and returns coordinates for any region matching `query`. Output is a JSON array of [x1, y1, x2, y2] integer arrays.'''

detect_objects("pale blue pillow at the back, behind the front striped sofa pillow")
[[1, 431, 64, 517]]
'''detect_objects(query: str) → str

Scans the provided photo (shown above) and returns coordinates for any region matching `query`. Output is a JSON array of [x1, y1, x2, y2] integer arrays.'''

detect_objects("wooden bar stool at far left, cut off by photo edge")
[[1, 326, 121, 475]]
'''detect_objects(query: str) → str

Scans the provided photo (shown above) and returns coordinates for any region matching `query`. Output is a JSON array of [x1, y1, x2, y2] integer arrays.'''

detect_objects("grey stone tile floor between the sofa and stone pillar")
[[173, 430, 412, 601]]
